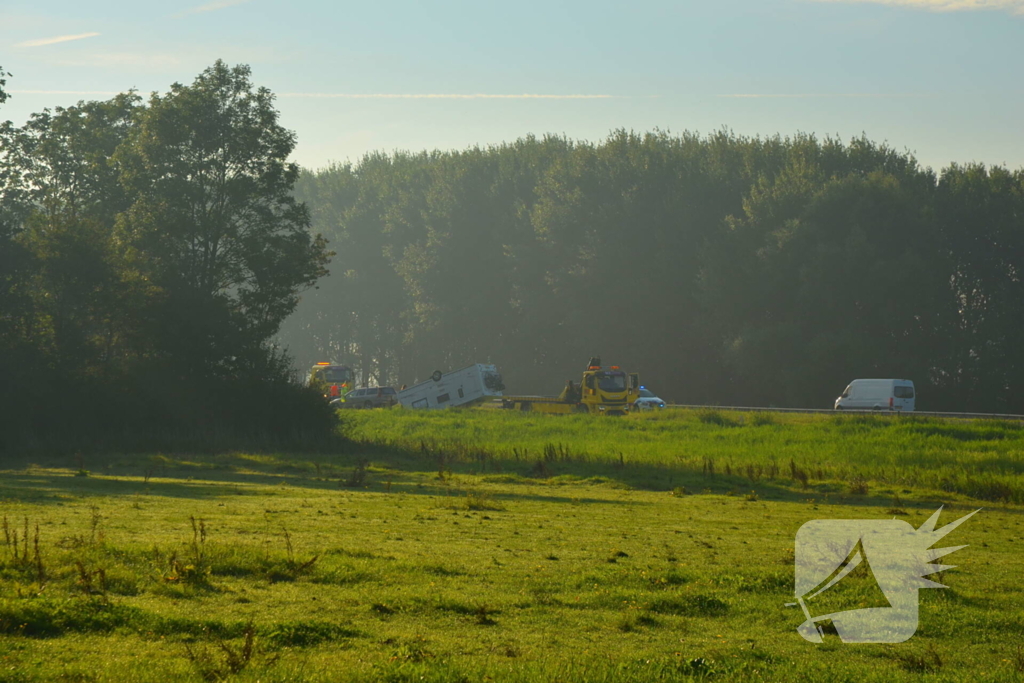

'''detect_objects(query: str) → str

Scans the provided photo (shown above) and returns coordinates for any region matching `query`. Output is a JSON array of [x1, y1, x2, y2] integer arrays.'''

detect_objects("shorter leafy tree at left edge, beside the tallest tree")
[[0, 92, 139, 368]]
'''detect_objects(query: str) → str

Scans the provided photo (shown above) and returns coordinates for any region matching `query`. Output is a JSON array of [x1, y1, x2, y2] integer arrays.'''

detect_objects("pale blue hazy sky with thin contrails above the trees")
[[0, 0, 1024, 174]]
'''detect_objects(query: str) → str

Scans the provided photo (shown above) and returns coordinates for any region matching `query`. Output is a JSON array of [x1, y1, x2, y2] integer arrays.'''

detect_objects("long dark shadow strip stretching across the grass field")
[[0, 444, 1022, 512]]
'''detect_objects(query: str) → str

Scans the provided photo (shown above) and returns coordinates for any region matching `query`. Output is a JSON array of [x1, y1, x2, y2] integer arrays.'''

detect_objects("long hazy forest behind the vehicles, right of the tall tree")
[[280, 131, 1024, 413]]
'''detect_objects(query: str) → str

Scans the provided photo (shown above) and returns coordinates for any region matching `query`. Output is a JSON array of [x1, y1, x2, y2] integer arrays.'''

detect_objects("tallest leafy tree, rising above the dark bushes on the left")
[[115, 60, 330, 373]]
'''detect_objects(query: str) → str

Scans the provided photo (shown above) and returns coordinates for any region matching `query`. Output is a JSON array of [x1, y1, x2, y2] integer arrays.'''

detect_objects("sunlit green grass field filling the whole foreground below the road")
[[0, 410, 1024, 683]]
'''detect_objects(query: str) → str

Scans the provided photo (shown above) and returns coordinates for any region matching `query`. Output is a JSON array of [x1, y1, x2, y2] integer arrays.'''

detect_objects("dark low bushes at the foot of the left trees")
[[0, 364, 337, 452]]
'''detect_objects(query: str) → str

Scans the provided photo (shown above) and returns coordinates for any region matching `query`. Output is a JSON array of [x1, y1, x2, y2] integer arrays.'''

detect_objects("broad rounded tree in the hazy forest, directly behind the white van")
[[702, 141, 951, 407]]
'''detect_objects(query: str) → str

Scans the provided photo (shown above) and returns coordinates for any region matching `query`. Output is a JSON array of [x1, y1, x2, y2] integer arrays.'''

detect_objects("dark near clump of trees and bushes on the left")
[[0, 61, 332, 449]]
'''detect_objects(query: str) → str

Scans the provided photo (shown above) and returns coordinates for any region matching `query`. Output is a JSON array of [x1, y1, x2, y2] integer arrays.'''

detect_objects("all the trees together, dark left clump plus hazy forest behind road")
[[0, 61, 1024, 450]]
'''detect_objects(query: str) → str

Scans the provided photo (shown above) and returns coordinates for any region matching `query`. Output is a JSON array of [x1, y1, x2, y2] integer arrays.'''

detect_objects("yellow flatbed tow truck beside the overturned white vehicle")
[[502, 356, 640, 415]]
